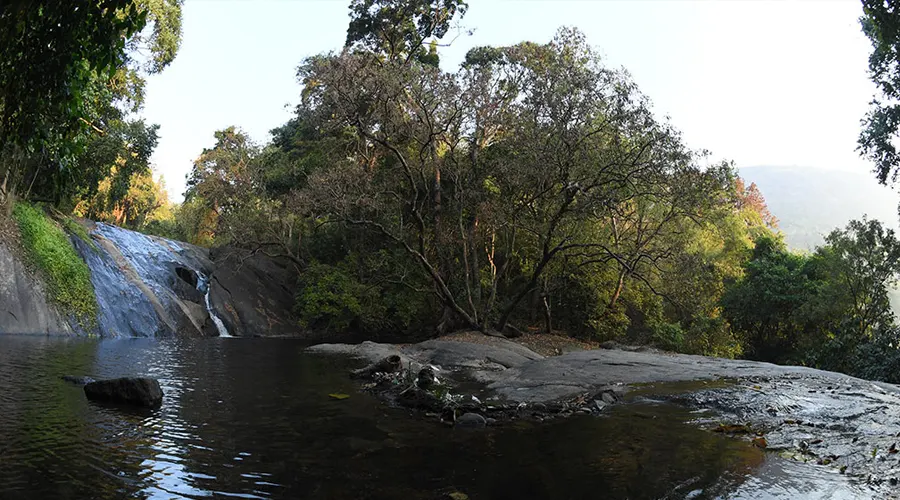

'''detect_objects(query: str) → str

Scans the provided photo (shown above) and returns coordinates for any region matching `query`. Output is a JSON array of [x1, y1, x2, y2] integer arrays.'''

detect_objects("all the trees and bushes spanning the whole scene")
[[0, 0, 900, 380]]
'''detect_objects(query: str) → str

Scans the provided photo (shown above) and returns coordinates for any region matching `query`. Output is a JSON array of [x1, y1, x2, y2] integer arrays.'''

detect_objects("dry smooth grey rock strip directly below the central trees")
[[309, 337, 900, 403]]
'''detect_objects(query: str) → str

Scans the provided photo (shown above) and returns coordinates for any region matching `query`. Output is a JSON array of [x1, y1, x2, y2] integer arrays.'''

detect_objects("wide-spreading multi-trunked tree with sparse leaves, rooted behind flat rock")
[[300, 30, 720, 338]]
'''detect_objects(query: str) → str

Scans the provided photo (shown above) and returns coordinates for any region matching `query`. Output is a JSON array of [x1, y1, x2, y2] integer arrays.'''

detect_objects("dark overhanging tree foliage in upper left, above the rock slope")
[[0, 0, 181, 213]]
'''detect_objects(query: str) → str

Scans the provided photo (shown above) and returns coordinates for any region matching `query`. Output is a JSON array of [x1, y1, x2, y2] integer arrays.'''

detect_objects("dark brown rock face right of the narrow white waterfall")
[[209, 248, 299, 337]]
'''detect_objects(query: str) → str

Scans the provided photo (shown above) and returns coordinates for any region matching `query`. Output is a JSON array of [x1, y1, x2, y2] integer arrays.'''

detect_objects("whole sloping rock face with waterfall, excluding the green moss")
[[0, 215, 300, 337]]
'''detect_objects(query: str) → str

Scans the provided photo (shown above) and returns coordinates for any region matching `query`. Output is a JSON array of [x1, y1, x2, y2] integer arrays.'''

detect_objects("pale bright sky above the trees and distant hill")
[[143, 0, 874, 201]]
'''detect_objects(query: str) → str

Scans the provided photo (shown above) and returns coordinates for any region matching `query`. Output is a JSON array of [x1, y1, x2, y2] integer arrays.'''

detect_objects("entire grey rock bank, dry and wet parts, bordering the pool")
[[308, 337, 900, 494]]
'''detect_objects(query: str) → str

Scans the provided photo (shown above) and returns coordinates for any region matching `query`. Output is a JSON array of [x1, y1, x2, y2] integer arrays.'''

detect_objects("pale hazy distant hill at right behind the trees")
[[740, 166, 900, 250]]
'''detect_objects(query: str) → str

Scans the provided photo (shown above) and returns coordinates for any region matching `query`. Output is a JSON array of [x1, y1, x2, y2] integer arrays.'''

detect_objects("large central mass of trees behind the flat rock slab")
[[169, 1, 775, 356]]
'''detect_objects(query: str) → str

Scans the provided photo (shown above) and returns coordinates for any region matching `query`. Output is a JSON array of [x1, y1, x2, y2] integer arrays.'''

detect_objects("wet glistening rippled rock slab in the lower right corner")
[[671, 374, 900, 490]]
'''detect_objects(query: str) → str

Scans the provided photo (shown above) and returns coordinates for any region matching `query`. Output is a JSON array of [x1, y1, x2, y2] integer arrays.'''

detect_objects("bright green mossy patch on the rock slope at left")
[[13, 203, 97, 327]]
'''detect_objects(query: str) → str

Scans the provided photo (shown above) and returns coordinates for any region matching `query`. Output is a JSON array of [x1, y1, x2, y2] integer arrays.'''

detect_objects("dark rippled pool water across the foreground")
[[0, 336, 872, 500]]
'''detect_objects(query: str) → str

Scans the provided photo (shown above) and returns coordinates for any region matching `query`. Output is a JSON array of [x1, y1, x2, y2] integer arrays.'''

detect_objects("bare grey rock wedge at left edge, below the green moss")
[[0, 241, 74, 334]]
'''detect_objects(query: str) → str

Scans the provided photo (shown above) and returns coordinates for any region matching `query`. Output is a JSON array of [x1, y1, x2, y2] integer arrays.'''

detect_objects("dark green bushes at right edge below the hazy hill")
[[723, 219, 900, 382]]
